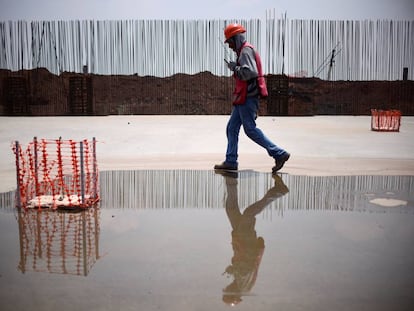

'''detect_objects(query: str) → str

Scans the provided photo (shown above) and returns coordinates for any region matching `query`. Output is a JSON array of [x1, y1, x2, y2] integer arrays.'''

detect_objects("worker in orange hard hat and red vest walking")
[[214, 24, 290, 174]]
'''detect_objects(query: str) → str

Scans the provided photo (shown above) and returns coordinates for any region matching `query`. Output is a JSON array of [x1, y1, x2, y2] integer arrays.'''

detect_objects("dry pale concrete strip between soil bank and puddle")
[[0, 116, 414, 192]]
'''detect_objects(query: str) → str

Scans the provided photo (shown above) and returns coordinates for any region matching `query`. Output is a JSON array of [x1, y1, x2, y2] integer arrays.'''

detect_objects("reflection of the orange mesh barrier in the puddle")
[[18, 207, 100, 276]]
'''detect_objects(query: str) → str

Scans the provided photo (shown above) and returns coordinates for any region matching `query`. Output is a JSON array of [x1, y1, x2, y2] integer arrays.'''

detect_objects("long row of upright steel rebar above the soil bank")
[[0, 18, 414, 80]]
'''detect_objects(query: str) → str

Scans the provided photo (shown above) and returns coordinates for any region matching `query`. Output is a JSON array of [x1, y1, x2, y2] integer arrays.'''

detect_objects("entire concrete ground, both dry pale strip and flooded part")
[[0, 116, 414, 311]]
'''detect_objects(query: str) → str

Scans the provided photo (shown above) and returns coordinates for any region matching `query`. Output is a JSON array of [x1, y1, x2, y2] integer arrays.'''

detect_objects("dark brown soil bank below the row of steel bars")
[[0, 69, 414, 116]]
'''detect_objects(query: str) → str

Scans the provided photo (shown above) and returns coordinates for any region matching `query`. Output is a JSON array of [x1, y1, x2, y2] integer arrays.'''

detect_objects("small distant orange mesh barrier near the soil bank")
[[371, 109, 401, 132]]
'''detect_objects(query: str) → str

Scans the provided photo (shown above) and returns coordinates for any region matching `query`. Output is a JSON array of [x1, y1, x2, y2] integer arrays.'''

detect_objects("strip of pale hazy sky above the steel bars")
[[0, 0, 414, 21]]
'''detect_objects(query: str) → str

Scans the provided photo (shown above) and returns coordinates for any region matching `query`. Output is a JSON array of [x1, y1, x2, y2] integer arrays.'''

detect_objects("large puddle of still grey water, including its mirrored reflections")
[[0, 170, 414, 310]]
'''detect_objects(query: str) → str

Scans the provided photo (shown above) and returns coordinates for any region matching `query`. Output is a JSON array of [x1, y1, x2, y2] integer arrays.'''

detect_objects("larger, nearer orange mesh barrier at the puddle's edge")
[[13, 138, 99, 209]]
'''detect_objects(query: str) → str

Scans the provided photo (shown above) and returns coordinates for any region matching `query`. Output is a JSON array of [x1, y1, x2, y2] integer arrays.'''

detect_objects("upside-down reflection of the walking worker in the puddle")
[[223, 175, 289, 305]]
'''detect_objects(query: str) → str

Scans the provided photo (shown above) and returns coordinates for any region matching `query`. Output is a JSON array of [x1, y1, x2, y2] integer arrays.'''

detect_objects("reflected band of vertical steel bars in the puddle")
[[100, 170, 414, 213]]
